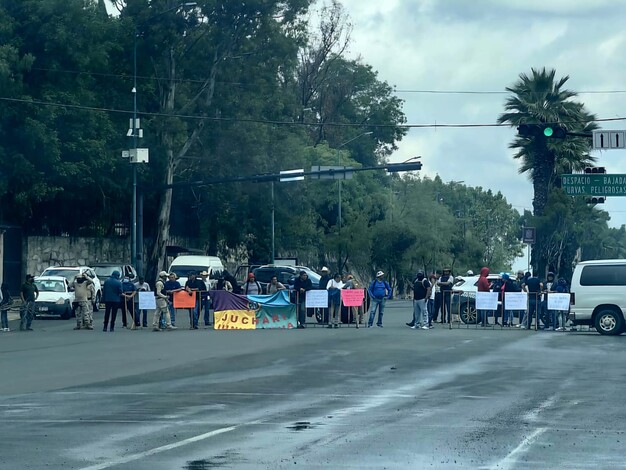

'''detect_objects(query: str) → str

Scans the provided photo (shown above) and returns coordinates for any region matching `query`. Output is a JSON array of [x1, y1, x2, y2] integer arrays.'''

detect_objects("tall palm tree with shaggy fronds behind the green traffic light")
[[498, 67, 598, 216]]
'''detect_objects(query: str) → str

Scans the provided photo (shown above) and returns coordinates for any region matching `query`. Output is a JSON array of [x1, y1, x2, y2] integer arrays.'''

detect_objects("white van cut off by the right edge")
[[569, 259, 626, 335]]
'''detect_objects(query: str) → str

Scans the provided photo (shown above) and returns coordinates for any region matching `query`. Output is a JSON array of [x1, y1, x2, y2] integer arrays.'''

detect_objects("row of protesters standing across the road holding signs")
[[0, 267, 568, 332]]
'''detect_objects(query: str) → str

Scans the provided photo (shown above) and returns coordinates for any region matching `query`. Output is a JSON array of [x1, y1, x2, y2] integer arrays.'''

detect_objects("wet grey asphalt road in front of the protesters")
[[0, 301, 626, 470]]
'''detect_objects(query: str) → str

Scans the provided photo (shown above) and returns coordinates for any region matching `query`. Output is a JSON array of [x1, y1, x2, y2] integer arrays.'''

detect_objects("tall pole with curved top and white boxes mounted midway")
[[127, 2, 197, 275]]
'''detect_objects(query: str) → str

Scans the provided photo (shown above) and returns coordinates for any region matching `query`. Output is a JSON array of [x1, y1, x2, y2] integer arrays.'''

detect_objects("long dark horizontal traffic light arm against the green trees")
[[165, 162, 422, 188]]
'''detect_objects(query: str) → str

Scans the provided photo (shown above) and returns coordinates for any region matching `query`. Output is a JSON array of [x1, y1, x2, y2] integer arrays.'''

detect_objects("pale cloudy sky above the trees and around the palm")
[[341, 0, 626, 232]]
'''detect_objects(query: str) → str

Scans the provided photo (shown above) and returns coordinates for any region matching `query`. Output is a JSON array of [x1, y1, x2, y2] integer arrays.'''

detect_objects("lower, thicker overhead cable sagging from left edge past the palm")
[[0, 96, 626, 129]]
